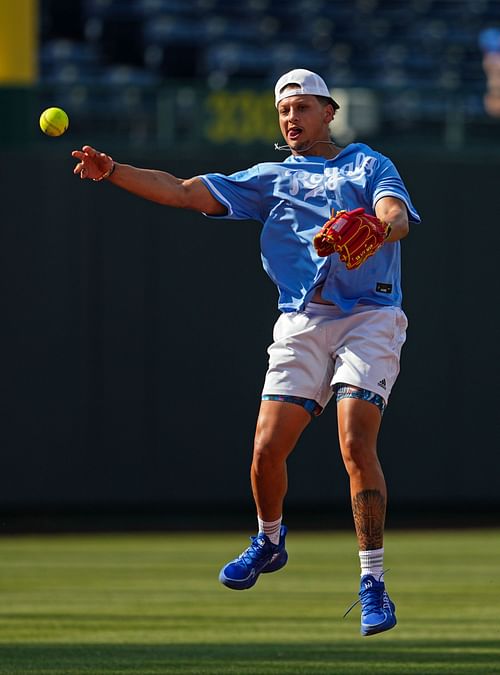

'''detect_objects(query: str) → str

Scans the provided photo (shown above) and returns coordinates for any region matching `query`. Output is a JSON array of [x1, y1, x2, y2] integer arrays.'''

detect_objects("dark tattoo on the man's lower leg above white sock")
[[352, 490, 386, 551]]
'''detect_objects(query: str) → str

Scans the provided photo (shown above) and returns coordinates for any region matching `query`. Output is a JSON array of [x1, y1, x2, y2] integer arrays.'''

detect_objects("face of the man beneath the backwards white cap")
[[278, 94, 334, 153]]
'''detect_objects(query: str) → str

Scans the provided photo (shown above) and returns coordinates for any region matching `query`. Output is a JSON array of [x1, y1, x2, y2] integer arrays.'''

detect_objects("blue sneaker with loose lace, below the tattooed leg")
[[359, 574, 397, 635]]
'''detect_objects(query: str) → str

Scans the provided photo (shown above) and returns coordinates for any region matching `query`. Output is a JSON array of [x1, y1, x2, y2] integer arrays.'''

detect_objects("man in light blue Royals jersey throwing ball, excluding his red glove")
[[72, 69, 420, 635]]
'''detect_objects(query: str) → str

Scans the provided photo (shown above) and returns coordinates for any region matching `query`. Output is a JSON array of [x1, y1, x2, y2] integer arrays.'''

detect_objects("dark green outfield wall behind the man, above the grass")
[[0, 144, 500, 509]]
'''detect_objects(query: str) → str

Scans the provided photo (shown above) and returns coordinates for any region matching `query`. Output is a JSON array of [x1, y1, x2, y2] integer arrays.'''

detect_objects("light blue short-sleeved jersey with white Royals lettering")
[[200, 143, 420, 312]]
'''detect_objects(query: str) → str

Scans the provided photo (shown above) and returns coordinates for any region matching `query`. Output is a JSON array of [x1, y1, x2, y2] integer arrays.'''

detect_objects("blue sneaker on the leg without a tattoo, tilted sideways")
[[219, 525, 288, 591]]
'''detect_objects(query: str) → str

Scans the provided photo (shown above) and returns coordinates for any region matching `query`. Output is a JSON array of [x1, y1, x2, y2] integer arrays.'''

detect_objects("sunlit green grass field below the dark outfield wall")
[[0, 530, 500, 675]]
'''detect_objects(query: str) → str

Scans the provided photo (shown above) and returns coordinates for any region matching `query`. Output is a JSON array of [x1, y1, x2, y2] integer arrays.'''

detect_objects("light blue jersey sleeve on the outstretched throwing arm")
[[200, 165, 262, 221]]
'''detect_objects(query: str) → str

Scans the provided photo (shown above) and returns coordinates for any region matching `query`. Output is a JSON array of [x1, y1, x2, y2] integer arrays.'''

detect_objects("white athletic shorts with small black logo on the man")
[[262, 302, 408, 408]]
